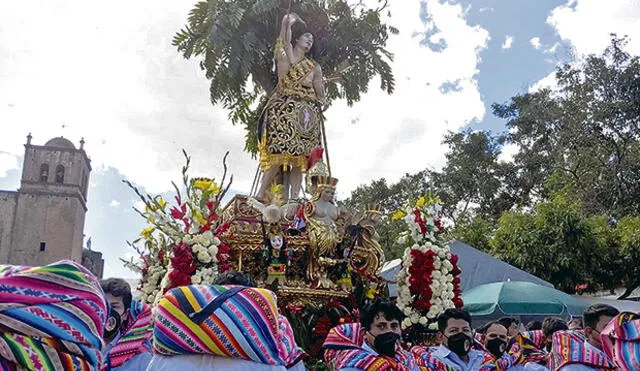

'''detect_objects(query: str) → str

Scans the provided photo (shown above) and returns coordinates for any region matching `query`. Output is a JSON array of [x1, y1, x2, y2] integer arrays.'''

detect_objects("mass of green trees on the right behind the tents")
[[346, 35, 640, 297]]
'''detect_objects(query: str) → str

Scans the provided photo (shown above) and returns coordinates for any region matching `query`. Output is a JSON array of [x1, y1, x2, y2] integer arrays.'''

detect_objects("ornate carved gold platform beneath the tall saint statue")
[[220, 195, 383, 305]]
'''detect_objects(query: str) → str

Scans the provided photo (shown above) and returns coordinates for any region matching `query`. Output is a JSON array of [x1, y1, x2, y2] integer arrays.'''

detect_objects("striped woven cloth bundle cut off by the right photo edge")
[[600, 312, 640, 371]]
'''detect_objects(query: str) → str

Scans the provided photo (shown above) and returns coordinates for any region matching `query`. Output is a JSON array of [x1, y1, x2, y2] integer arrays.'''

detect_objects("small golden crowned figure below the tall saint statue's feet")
[[304, 176, 343, 288]]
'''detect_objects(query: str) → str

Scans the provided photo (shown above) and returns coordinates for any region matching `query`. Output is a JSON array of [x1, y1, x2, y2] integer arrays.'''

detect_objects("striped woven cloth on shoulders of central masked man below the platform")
[[322, 323, 418, 371]]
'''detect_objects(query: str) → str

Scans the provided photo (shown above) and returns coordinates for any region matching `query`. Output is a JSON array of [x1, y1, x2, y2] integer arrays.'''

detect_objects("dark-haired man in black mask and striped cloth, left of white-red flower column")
[[323, 299, 419, 371]]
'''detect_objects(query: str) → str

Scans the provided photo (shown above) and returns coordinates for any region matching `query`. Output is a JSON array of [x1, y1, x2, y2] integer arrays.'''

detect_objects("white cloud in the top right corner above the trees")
[[547, 0, 640, 55]]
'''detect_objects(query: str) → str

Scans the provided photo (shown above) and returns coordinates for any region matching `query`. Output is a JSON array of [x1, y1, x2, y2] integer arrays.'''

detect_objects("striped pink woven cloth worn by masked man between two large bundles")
[[105, 300, 153, 369]]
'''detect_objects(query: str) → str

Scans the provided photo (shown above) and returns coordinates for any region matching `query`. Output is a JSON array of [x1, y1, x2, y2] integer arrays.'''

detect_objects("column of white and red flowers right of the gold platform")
[[392, 194, 463, 330]]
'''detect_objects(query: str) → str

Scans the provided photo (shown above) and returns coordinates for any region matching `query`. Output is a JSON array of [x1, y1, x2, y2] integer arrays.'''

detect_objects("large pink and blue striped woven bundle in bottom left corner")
[[0, 260, 107, 371]]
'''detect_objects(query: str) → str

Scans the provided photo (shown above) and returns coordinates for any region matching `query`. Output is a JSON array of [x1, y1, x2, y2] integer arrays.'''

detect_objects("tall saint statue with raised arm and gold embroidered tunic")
[[257, 13, 326, 200]]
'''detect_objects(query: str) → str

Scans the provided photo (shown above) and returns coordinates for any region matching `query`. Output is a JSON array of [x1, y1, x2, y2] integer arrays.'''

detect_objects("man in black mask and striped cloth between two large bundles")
[[100, 278, 153, 371]]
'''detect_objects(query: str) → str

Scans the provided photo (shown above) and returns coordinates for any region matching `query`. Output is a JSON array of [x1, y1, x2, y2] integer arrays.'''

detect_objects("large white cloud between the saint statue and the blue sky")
[[326, 0, 489, 197]]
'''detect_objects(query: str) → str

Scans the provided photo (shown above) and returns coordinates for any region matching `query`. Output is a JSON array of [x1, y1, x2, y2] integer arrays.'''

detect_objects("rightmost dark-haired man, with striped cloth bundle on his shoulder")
[[550, 304, 619, 371]]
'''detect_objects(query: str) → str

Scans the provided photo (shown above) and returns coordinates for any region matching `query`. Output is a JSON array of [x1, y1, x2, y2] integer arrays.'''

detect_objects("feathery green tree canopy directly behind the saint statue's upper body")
[[173, 0, 397, 153]]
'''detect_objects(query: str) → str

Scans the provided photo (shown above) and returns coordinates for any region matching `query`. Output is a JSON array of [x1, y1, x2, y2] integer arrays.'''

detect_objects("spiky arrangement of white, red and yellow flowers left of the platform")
[[123, 151, 233, 303]]
